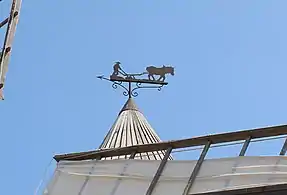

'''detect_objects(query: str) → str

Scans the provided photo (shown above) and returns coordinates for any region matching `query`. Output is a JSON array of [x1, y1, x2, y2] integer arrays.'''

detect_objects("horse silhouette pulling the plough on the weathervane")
[[146, 66, 174, 82]]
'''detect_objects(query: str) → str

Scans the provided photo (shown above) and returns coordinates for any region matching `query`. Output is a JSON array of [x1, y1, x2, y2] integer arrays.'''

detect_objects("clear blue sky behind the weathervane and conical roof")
[[0, 0, 287, 195]]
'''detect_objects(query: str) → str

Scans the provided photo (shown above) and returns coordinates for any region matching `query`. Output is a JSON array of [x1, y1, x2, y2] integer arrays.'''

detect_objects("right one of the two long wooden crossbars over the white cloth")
[[182, 141, 211, 195]]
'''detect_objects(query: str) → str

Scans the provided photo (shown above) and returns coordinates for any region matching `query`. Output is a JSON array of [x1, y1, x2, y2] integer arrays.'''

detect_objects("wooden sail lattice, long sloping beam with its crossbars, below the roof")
[[54, 125, 287, 195]]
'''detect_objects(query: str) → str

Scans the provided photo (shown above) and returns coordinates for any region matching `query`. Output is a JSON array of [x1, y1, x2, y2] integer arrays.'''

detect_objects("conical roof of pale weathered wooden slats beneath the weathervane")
[[99, 98, 171, 160]]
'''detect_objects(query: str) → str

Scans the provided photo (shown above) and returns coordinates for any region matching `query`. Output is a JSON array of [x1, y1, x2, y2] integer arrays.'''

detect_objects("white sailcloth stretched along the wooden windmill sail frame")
[[44, 156, 287, 195]]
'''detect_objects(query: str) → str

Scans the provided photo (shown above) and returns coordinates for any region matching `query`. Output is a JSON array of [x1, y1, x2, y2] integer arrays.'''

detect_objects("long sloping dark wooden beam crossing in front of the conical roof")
[[54, 125, 287, 162]]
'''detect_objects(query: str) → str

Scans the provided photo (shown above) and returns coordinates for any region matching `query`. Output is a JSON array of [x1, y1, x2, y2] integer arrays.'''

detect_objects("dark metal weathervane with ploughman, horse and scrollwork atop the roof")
[[97, 62, 174, 98]]
